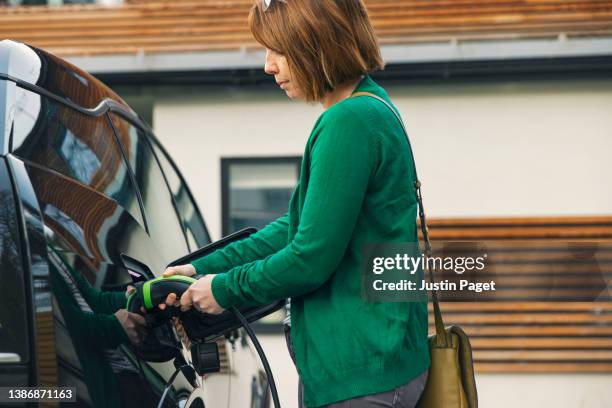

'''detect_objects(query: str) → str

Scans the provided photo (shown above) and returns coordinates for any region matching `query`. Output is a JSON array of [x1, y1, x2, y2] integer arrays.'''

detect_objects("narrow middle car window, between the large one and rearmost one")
[[110, 113, 189, 263]]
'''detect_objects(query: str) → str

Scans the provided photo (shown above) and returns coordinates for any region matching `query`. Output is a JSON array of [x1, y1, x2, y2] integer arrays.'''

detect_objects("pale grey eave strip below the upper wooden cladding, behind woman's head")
[[65, 35, 612, 75]]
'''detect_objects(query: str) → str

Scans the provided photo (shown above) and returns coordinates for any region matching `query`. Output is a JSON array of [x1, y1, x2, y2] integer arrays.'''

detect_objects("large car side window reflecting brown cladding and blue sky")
[[12, 90, 143, 230]]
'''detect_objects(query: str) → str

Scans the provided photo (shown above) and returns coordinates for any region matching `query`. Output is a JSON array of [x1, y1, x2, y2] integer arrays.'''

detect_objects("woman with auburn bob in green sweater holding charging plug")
[[160, 0, 430, 408]]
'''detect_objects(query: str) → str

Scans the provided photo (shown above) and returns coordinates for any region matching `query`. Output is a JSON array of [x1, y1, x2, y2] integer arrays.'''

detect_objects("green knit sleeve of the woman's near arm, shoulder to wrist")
[[212, 103, 378, 308]]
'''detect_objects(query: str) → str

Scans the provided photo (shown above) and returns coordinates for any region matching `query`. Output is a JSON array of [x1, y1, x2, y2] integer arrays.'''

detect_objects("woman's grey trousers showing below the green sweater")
[[285, 325, 429, 408]]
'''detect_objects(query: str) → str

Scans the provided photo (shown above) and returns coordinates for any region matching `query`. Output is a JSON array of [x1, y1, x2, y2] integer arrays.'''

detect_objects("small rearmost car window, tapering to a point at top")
[[152, 142, 210, 251]]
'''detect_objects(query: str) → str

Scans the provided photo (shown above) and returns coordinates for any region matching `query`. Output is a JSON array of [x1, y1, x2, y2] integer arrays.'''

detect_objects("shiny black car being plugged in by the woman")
[[0, 40, 274, 407]]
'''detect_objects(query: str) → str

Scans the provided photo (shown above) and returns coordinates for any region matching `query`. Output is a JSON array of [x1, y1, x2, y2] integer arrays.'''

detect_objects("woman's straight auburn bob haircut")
[[249, 0, 384, 102]]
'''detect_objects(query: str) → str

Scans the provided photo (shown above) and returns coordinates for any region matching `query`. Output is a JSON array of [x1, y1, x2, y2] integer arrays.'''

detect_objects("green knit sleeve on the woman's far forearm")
[[191, 214, 289, 275]]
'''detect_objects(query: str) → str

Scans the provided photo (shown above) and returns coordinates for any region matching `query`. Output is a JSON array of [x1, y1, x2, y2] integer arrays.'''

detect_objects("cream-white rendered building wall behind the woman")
[[153, 81, 612, 408]]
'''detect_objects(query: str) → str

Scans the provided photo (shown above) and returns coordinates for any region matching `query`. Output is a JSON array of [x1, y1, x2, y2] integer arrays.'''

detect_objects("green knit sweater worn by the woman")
[[193, 76, 430, 407]]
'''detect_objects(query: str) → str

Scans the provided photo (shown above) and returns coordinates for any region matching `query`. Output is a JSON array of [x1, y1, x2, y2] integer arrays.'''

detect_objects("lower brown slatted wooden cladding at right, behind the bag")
[[420, 216, 612, 373]]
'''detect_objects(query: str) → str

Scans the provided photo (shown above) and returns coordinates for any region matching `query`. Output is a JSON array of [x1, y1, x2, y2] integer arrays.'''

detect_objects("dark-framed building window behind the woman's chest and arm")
[[221, 157, 301, 235]]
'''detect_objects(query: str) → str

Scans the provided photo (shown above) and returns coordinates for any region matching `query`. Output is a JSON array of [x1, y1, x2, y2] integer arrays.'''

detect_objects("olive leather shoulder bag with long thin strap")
[[351, 92, 478, 408]]
